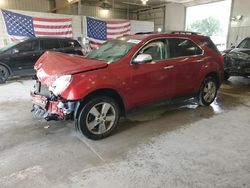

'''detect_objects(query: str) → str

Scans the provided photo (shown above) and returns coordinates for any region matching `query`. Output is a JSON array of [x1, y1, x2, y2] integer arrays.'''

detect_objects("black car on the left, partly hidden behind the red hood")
[[0, 38, 83, 83]]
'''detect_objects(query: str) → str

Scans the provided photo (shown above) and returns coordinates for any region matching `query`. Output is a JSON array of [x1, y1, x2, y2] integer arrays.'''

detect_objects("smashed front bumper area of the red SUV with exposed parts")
[[30, 93, 76, 121]]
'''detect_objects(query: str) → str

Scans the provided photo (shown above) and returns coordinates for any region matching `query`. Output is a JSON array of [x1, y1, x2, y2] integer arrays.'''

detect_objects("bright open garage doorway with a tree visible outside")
[[186, 0, 232, 51]]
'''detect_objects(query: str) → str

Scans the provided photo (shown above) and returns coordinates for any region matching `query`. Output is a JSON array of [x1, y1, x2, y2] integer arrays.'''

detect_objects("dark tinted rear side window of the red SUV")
[[168, 38, 202, 58]]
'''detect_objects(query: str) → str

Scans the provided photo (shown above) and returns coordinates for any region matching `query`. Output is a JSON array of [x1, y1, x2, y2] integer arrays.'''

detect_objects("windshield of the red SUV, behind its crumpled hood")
[[87, 39, 136, 63]]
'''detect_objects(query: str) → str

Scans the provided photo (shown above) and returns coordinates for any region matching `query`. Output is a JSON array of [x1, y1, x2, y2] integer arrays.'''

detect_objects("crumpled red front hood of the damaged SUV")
[[34, 51, 108, 85]]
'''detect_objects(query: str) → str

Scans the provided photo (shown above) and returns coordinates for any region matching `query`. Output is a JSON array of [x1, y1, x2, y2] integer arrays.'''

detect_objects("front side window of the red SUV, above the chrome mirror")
[[139, 40, 166, 60]]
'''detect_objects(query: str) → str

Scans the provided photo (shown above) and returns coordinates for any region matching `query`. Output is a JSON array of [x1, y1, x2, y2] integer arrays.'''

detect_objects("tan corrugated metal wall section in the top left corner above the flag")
[[0, 0, 50, 12]]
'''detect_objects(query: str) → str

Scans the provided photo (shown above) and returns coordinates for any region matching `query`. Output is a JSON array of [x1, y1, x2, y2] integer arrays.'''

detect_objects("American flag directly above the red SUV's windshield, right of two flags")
[[87, 17, 131, 48]]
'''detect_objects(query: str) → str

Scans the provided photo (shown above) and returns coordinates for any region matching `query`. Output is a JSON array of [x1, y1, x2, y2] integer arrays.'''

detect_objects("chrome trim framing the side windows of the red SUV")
[[130, 37, 204, 65]]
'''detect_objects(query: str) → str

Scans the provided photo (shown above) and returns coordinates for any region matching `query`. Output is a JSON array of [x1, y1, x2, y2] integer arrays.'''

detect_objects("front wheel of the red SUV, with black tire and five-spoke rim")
[[76, 96, 120, 140]]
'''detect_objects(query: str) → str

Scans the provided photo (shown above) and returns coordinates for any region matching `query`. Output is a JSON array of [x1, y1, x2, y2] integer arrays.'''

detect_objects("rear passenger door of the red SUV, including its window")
[[167, 38, 203, 96]]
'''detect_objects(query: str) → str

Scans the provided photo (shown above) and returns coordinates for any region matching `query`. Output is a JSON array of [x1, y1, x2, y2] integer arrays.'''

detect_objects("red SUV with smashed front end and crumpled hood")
[[31, 33, 223, 140]]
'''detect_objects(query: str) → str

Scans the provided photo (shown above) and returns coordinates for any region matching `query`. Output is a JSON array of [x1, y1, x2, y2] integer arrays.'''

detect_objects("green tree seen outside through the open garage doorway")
[[188, 16, 221, 37]]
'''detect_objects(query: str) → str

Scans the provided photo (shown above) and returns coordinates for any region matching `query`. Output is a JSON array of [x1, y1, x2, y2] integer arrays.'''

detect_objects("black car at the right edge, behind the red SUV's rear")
[[224, 37, 250, 80]]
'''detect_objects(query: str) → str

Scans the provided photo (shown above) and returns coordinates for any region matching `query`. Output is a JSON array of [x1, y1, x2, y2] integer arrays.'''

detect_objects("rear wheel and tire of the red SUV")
[[198, 76, 218, 106]]
